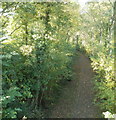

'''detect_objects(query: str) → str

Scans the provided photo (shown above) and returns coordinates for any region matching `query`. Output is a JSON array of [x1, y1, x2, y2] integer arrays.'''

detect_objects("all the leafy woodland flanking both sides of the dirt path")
[[0, 2, 116, 118]]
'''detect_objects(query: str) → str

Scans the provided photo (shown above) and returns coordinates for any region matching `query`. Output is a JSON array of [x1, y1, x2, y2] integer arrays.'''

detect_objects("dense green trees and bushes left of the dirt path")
[[1, 2, 78, 118]]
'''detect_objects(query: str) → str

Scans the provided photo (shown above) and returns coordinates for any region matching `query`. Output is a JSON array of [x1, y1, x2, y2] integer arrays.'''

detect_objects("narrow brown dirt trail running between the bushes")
[[49, 53, 100, 118]]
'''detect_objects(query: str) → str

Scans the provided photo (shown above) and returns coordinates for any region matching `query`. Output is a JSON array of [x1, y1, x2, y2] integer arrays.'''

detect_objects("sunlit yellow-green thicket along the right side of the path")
[[79, 2, 116, 114]]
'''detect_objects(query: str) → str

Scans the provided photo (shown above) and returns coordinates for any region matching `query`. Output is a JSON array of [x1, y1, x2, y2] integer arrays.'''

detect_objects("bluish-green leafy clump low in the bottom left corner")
[[2, 87, 22, 118]]
